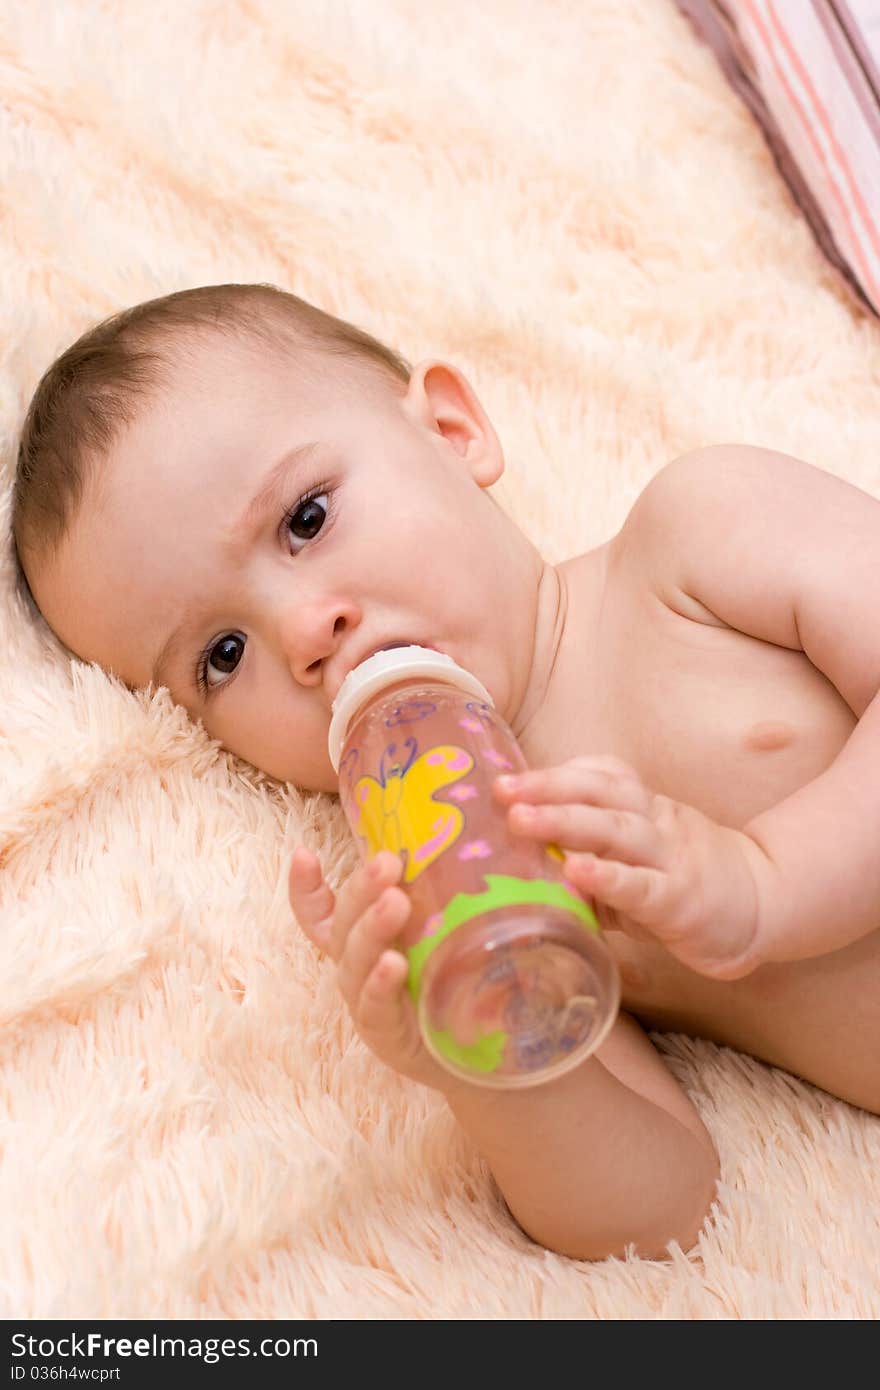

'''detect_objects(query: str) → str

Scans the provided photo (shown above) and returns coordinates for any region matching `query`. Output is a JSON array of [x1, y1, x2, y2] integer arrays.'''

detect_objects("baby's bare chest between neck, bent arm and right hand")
[[539, 581, 855, 827]]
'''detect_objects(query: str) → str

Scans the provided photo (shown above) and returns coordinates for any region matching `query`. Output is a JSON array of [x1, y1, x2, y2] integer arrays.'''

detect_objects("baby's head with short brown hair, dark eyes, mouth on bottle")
[[13, 285, 544, 791]]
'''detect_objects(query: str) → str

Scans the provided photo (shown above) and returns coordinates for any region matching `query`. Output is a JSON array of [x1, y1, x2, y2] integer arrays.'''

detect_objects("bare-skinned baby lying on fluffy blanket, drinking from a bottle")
[[13, 285, 880, 1259]]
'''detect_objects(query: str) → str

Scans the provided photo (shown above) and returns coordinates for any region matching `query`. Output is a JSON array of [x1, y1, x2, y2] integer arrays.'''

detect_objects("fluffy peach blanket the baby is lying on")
[[0, 0, 880, 1319]]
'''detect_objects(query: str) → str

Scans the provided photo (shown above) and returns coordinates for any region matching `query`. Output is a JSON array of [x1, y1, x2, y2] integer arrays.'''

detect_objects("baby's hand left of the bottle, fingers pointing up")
[[288, 845, 464, 1091]]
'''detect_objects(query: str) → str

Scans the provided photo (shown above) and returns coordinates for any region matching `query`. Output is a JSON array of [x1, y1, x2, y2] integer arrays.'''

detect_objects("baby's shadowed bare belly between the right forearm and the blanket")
[[608, 930, 880, 1115]]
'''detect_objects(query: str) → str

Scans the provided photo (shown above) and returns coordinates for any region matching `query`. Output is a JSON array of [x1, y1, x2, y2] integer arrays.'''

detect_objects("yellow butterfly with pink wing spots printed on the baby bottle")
[[353, 738, 474, 883]]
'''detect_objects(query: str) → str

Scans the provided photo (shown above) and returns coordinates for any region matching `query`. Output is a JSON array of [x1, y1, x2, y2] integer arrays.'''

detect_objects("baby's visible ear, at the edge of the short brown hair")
[[403, 357, 505, 488]]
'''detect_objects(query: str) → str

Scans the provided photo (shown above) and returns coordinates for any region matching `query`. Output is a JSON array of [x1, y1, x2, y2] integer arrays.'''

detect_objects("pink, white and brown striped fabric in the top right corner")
[[677, 0, 880, 314]]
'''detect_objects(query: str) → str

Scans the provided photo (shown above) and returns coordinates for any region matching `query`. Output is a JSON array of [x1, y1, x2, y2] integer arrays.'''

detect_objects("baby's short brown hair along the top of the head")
[[13, 284, 410, 606]]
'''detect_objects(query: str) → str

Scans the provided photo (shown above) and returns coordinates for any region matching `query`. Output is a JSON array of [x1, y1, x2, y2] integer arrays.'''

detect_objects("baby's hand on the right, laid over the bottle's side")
[[494, 758, 763, 980]]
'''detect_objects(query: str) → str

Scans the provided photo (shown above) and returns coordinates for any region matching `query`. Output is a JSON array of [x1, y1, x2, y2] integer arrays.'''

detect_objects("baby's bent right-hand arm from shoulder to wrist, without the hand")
[[617, 445, 880, 973]]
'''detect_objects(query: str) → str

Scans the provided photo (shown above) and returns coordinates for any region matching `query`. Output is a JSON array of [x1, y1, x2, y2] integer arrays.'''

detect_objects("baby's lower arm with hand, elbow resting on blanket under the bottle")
[[291, 851, 717, 1259]]
